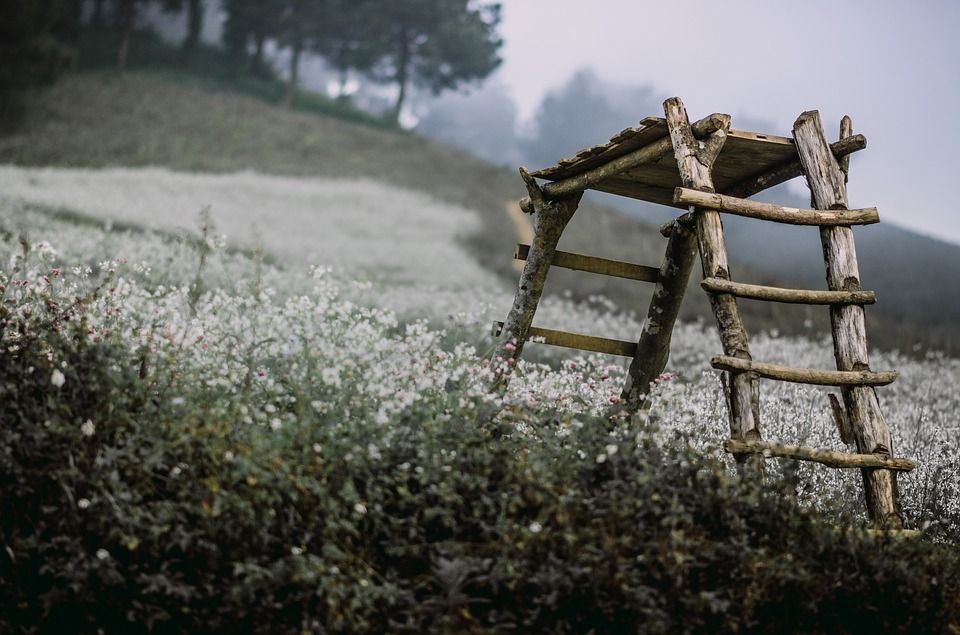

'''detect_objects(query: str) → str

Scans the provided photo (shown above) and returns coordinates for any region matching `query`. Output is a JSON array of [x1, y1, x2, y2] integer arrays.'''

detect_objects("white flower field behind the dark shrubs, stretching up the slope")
[[0, 167, 960, 533]]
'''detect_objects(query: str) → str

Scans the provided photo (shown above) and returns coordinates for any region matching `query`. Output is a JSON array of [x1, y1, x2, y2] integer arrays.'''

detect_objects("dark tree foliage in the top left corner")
[[0, 0, 72, 120]]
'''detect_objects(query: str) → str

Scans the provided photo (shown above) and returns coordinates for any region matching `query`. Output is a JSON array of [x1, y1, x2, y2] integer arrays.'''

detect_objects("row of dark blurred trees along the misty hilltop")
[[0, 0, 502, 121]]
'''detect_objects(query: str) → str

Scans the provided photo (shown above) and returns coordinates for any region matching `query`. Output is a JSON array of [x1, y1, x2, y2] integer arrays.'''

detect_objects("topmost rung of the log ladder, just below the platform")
[[673, 187, 880, 227]]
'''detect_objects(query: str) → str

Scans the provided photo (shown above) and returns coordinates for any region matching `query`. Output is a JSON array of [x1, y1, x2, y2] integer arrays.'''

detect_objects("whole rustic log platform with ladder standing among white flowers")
[[494, 98, 915, 529]]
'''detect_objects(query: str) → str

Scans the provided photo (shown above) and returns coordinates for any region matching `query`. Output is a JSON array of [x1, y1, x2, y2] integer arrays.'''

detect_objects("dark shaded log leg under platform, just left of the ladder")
[[608, 222, 697, 416]]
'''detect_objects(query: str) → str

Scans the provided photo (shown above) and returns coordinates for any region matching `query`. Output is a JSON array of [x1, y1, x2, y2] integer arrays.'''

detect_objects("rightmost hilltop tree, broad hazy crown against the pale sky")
[[369, 0, 502, 122]]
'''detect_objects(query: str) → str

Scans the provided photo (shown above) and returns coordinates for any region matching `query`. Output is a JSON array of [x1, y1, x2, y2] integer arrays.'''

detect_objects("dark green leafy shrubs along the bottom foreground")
[[0, 325, 960, 633]]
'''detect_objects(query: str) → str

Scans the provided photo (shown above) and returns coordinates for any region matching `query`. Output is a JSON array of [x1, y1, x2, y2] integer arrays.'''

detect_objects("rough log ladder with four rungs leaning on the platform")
[[664, 98, 916, 529]]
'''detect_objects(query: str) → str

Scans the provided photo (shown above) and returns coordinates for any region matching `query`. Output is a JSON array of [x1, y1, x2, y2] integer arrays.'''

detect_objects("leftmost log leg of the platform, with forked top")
[[494, 168, 583, 381]]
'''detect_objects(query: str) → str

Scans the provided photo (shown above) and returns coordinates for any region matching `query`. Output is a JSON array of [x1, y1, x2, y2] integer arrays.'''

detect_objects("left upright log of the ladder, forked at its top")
[[663, 97, 763, 471]]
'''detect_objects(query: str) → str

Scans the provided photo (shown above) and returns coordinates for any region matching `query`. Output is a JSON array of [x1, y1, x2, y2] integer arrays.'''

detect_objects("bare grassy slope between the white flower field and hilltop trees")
[[0, 70, 960, 352]]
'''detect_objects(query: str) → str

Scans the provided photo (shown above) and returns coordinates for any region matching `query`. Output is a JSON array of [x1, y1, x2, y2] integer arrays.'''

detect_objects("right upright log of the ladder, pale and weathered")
[[793, 111, 903, 529]]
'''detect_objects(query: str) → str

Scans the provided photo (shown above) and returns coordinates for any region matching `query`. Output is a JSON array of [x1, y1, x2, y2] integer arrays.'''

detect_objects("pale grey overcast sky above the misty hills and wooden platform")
[[495, 0, 960, 244]]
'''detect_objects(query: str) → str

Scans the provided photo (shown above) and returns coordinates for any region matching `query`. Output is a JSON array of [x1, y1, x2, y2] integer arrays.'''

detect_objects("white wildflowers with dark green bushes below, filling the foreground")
[[0, 221, 960, 633]]
